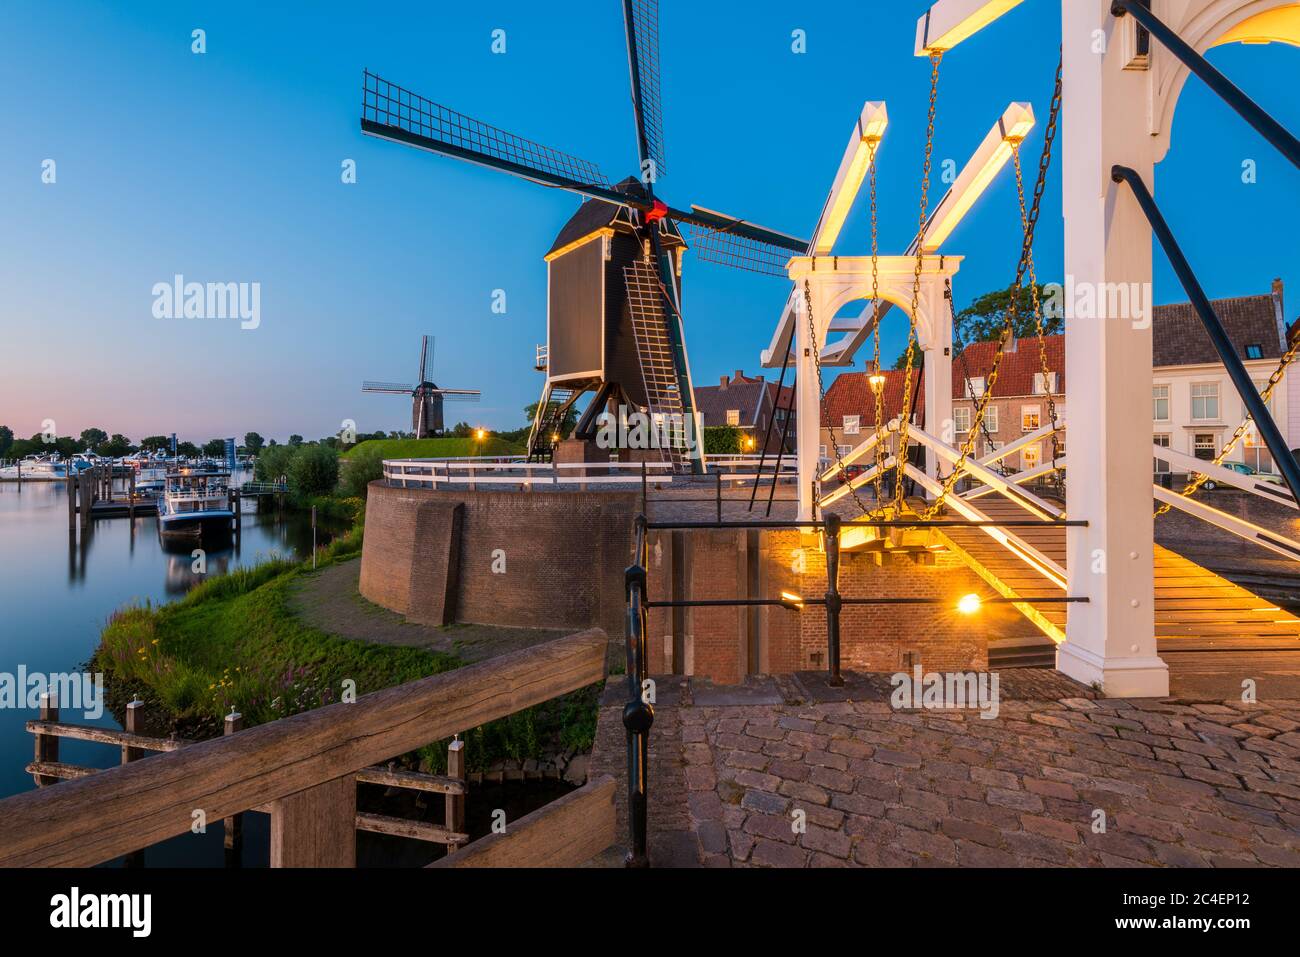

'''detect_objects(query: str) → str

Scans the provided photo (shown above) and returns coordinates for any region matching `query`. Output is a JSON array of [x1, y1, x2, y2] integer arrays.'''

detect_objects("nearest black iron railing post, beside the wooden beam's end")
[[623, 515, 654, 867]]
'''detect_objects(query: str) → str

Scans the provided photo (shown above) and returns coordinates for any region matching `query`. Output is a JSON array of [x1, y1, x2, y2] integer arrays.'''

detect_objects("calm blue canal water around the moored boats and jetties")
[[0, 473, 342, 867]]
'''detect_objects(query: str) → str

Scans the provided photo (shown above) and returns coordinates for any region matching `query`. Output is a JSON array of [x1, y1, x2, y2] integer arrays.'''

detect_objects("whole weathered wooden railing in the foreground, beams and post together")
[[0, 629, 614, 867]]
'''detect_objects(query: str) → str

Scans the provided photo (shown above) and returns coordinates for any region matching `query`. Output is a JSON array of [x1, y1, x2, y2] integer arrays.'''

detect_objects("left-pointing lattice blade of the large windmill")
[[361, 70, 607, 189]]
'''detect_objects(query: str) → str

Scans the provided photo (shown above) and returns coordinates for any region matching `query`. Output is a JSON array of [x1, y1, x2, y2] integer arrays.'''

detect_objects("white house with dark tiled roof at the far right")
[[1151, 280, 1300, 472]]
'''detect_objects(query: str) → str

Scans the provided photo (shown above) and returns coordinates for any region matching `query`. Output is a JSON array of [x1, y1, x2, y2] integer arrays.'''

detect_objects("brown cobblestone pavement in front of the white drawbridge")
[[594, 672, 1300, 867]]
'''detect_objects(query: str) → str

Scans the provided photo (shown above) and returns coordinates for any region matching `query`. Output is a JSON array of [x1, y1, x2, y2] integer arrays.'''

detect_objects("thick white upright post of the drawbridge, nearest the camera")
[[1057, 0, 1169, 697]]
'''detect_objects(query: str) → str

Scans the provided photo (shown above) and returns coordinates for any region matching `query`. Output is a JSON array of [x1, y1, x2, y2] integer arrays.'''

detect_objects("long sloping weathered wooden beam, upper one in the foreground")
[[0, 629, 607, 867]]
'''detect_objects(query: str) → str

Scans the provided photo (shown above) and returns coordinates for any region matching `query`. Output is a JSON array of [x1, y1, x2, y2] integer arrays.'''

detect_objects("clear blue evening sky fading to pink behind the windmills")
[[0, 0, 1300, 439]]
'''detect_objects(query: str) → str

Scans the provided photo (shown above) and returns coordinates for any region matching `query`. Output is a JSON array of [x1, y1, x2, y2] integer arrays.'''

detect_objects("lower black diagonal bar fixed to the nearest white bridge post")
[[1110, 166, 1300, 501]]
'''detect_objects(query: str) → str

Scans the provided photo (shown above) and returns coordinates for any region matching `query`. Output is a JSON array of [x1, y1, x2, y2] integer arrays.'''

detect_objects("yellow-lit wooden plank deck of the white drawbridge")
[[940, 497, 1300, 655]]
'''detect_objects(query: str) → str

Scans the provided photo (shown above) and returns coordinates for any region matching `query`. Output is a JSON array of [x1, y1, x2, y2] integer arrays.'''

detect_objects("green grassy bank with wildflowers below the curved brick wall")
[[92, 527, 597, 772]]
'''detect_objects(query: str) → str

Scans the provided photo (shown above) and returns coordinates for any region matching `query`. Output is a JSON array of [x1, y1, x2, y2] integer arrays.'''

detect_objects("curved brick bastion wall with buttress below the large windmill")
[[361, 482, 640, 636]]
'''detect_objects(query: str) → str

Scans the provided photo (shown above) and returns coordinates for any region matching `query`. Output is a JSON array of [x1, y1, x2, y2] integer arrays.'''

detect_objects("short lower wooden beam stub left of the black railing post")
[[429, 776, 615, 867]]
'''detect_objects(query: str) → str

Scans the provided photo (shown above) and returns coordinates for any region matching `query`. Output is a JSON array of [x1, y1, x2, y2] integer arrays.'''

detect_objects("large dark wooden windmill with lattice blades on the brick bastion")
[[361, 0, 807, 471]]
